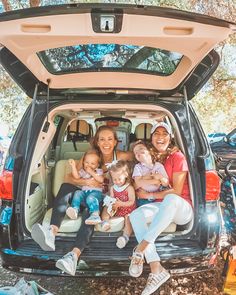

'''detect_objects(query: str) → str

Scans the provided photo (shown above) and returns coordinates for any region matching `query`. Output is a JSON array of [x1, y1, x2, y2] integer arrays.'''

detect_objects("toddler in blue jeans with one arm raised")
[[66, 150, 103, 225]]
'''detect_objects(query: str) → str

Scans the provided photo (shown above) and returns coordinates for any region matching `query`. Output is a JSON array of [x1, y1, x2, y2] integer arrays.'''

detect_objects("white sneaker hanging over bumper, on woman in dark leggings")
[[56, 252, 78, 276]]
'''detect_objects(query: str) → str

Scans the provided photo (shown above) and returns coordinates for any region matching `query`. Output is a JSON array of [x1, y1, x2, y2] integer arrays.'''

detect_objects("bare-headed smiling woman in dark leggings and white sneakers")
[[31, 126, 133, 275]]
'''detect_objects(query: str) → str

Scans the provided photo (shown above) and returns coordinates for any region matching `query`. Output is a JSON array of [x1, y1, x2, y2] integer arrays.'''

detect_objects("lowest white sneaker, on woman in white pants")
[[141, 268, 170, 295]]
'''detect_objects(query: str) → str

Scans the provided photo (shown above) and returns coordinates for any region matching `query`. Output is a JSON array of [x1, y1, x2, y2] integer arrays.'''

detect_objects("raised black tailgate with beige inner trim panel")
[[0, 4, 235, 99]]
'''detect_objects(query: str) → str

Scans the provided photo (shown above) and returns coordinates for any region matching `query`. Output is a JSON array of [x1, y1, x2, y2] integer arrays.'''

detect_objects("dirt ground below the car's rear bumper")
[[0, 259, 230, 295]]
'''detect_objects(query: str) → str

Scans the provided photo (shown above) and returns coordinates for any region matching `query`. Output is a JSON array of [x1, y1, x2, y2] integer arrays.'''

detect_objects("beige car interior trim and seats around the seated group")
[[25, 104, 193, 236]]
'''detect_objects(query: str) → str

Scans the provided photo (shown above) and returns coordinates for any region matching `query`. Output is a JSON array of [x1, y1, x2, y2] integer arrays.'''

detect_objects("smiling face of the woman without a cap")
[[97, 129, 117, 156]]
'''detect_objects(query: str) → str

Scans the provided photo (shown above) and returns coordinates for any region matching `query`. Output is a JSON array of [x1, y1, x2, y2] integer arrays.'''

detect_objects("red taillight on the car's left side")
[[0, 170, 13, 200]]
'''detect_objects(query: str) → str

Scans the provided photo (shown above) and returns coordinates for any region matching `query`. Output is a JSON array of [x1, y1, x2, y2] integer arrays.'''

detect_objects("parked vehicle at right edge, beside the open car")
[[211, 128, 236, 170]]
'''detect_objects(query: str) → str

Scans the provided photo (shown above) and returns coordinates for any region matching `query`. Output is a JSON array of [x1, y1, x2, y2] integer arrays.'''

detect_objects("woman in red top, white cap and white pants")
[[129, 122, 193, 295]]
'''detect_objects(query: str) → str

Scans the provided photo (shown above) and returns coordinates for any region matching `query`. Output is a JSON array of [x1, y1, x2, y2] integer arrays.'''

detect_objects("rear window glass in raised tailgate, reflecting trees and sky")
[[38, 44, 182, 76]]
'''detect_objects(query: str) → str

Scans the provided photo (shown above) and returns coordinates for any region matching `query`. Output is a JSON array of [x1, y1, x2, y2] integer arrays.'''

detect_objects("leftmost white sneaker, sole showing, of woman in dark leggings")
[[31, 223, 55, 251]]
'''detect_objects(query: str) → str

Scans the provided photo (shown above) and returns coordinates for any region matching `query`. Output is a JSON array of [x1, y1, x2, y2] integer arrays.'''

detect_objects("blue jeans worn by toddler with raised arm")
[[71, 190, 102, 213]]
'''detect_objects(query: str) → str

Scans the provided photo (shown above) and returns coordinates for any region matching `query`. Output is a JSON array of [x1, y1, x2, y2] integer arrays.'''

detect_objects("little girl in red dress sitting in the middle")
[[102, 161, 136, 248]]
